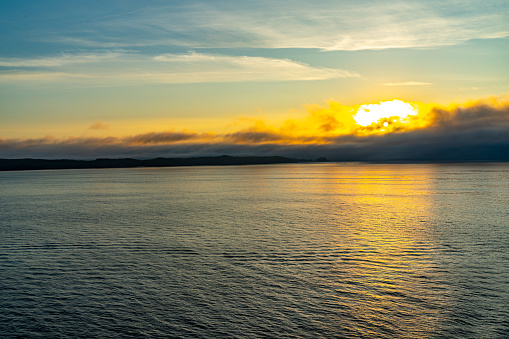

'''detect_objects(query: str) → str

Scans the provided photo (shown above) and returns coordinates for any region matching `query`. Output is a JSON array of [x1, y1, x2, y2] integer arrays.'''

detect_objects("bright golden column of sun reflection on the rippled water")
[[300, 165, 444, 337]]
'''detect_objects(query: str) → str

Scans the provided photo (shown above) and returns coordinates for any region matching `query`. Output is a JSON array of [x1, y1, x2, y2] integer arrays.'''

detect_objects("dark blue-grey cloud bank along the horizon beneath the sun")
[[0, 103, 509, 162]]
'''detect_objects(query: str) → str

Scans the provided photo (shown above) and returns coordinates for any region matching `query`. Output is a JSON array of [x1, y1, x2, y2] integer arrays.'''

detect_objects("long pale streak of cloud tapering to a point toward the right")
[[0, 51, 360, 86]]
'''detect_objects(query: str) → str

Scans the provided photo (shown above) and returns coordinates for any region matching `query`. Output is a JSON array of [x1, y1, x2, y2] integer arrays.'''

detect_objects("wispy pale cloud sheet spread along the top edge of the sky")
[[37, 0, 509, 51]]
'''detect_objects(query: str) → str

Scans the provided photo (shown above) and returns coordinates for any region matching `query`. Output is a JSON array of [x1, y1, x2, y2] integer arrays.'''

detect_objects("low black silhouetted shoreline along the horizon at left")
[[0, 155, 310, 171]]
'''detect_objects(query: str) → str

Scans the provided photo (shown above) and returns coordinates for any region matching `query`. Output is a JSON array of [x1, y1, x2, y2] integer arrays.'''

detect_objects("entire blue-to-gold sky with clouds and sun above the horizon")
[[0, 0, 509, 161]]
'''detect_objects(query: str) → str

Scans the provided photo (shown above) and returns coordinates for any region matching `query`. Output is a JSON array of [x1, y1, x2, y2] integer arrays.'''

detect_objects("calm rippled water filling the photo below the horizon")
[[0, 164, 509, 338]]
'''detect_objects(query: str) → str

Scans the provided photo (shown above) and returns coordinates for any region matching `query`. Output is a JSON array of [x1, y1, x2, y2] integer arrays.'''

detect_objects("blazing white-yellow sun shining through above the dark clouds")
[[353, 99, 418, 127]]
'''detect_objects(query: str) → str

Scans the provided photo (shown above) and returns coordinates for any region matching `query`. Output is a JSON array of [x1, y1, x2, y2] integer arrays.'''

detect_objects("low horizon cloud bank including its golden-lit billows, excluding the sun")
[[0, 96, 509, 162]]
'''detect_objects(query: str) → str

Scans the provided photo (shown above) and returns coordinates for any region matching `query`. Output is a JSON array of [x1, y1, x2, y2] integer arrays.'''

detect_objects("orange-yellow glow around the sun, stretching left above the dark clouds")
[[4, 95, 509, 146]]
